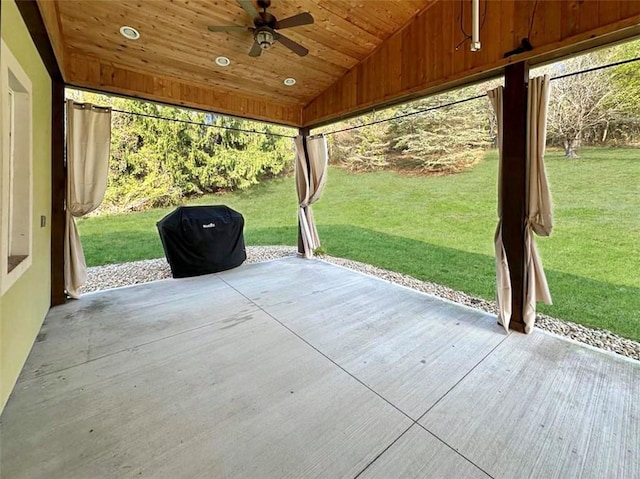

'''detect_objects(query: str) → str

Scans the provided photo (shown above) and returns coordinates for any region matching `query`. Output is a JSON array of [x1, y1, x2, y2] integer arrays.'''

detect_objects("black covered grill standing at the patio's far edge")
[[156, 205, 247, 278]]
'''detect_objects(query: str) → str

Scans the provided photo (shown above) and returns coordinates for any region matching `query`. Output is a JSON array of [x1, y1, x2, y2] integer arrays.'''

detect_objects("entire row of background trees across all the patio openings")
[[67, 40, 640, 212]]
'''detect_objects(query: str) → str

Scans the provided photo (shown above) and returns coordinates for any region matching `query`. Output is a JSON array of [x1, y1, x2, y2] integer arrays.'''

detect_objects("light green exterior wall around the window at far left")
[[0, 0, 51, 411]]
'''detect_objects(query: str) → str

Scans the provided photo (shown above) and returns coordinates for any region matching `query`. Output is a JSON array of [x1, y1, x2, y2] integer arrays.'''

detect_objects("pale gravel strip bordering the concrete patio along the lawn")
[[82, 246, 640, 360]]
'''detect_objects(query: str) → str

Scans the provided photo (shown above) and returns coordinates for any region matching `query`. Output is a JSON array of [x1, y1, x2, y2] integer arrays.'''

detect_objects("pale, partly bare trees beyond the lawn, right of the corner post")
[[327, 41, 640, 174]]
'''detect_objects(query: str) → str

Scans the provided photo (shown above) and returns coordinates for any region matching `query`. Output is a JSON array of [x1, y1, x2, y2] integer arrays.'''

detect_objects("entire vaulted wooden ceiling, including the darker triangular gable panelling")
[[38, 0, 640, 126]]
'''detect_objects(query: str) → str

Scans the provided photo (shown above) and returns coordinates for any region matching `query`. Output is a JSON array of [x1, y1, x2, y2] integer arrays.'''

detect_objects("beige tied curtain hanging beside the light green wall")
[[64, 100, 111, 298]]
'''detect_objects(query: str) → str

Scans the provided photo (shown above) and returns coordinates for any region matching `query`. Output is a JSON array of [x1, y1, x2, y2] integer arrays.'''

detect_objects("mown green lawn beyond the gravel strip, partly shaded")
[[78, 149, 640, 340]]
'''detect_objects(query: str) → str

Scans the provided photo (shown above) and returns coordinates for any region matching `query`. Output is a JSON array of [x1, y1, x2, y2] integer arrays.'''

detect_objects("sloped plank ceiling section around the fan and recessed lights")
[[40, 0, 434, 124]]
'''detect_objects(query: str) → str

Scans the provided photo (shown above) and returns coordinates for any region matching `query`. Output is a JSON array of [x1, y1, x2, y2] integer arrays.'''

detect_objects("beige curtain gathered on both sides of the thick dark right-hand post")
[[487, 75, 553, 333]]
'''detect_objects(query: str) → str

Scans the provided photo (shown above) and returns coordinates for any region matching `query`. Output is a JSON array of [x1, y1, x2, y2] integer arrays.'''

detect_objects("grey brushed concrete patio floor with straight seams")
[[0, 258, 640, 479]]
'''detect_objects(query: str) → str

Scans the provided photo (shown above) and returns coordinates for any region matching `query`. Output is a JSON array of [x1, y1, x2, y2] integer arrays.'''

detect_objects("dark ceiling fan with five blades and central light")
[[209, 0, 313, 57]]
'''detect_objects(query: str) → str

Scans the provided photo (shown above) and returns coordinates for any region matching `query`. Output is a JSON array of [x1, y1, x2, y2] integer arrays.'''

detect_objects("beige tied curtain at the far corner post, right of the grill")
[[294, 135, 329, 258]]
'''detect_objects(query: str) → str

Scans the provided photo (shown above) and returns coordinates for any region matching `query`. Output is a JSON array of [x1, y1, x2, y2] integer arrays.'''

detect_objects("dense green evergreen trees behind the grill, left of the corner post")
[[68, 91, 293, 211]]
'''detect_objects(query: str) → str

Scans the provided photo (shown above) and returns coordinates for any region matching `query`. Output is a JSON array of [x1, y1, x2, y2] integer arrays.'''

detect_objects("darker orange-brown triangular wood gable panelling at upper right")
[[302, 0, 640, 127]]
